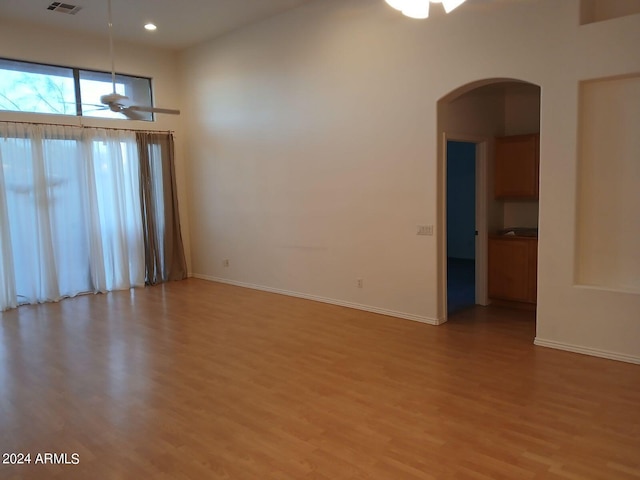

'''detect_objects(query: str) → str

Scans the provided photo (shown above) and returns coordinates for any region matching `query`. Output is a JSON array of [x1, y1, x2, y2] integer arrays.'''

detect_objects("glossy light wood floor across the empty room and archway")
[[0, 280, 640, 480]]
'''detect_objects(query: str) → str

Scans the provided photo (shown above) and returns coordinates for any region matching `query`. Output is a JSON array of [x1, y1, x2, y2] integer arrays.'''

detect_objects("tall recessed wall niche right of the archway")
[[575, 75, 640, 293]]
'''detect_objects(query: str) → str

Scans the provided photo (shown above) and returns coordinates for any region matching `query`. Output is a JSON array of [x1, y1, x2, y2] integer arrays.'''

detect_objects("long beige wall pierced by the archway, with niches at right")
[[183, 0, 640, 360]]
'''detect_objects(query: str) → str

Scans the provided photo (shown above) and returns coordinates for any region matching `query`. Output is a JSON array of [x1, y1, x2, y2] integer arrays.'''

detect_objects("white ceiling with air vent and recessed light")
[[0, 0, 313, 50]]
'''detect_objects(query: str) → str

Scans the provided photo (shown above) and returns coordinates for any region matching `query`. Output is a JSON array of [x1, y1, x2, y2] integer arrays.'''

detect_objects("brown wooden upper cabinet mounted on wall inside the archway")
[[495, 134, 540, 199]]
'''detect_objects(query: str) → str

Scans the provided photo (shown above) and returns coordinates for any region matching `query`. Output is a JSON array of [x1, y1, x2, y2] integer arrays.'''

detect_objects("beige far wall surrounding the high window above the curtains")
[[0, 18, 190, 270]]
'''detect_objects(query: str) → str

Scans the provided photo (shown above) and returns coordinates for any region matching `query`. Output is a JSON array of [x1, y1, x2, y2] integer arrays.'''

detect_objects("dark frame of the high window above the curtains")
[[0, 56, 155, 122]]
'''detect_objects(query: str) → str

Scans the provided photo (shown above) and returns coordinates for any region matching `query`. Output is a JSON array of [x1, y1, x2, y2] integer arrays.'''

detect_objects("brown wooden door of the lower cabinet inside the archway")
[[489, 238, 531, 302]]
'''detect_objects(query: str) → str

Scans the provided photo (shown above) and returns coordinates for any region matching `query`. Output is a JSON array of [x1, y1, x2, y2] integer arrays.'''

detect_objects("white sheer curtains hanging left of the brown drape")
[[0, 123, 145, 310]]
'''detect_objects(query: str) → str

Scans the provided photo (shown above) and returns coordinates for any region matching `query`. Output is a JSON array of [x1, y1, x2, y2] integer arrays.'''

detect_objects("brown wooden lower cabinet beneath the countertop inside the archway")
[[489, 236, 538, 304]]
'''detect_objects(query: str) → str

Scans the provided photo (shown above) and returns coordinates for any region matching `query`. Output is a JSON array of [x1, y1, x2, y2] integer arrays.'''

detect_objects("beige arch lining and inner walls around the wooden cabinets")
[[437, 78, 540, 322]]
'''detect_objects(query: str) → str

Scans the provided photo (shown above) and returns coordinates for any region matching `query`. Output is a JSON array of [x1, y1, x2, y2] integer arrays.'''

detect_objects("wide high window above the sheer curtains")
[[0, 58, 153, 121]]
